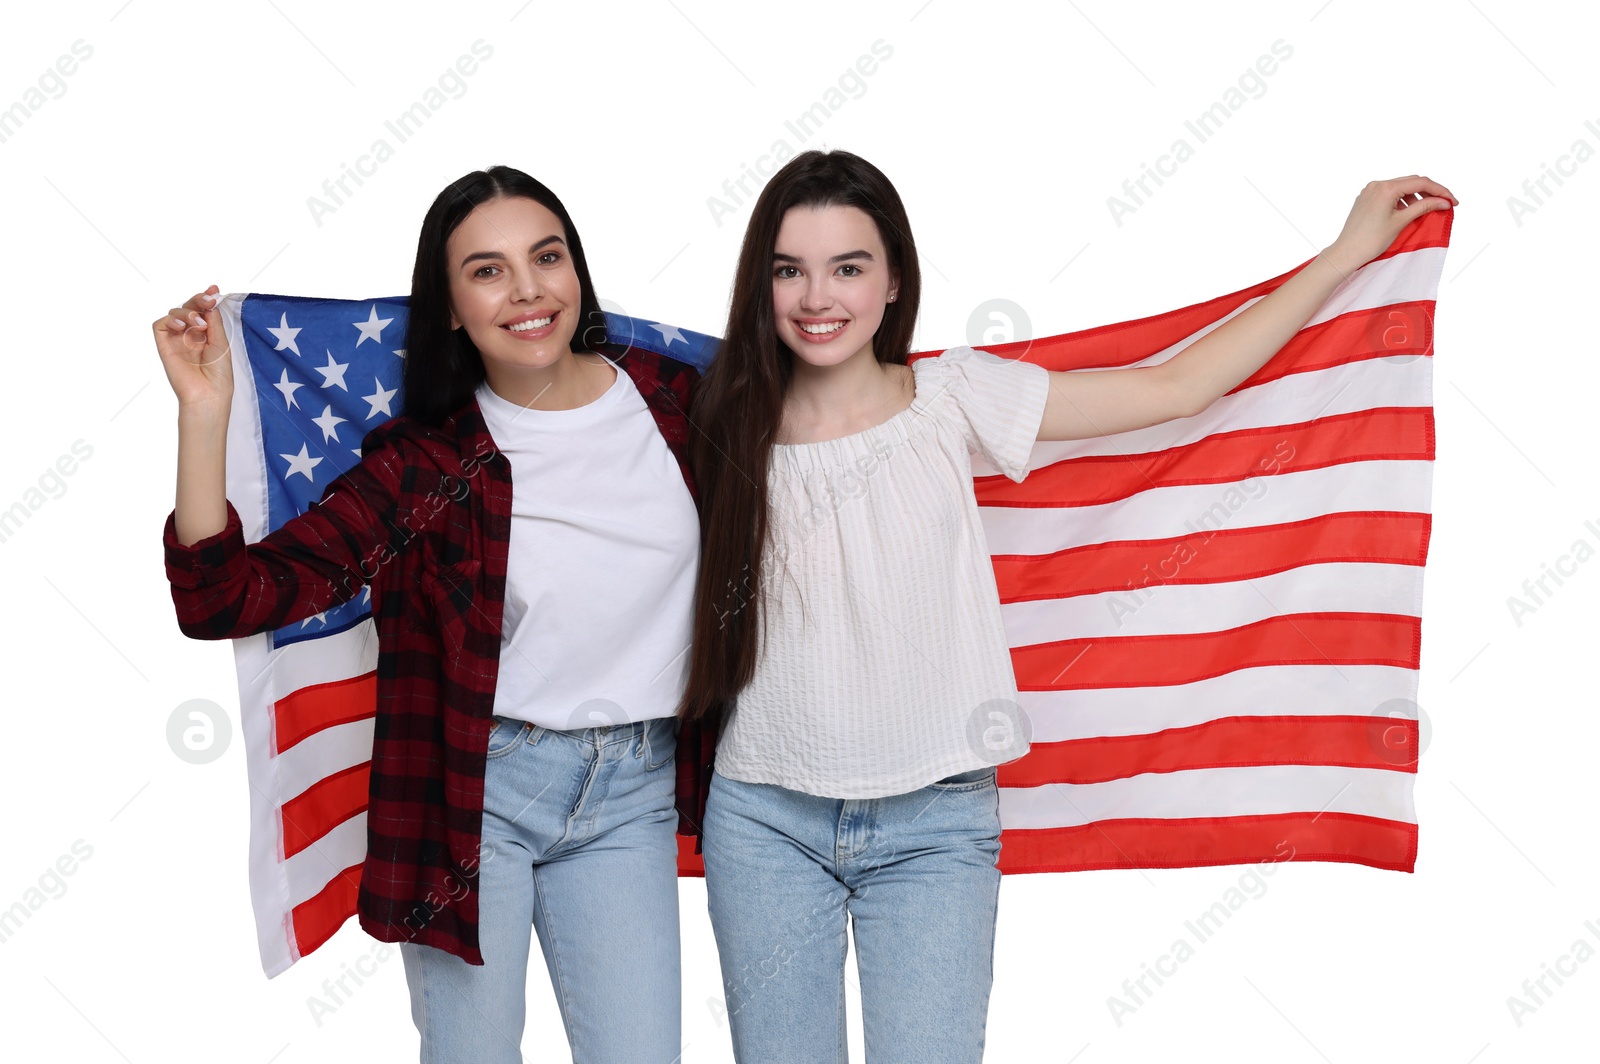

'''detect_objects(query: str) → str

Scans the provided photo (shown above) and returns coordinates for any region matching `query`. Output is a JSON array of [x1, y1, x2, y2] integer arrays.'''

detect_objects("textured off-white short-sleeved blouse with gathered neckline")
[[717, 347, 1050, 798]]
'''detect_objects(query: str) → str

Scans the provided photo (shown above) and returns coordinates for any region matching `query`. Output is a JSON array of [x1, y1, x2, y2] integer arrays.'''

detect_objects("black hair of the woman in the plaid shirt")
[[402, 166, 605, 426]]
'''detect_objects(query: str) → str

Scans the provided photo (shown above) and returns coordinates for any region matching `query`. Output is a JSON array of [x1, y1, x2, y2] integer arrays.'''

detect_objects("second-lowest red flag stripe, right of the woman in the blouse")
[[998, 715, 1418, 787]]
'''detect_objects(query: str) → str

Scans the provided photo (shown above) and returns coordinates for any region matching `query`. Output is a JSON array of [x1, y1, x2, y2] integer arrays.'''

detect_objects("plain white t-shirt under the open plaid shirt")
[[477, 368, 699, 731]]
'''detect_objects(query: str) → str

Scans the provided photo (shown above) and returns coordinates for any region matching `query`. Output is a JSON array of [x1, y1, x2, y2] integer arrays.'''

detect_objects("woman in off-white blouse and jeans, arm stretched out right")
[[682, 152, 1454, 1064]]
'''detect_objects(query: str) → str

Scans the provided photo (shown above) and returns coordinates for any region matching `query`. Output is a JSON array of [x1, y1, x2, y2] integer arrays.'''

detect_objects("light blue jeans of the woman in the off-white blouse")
[[704, 768, 1000, 1064]]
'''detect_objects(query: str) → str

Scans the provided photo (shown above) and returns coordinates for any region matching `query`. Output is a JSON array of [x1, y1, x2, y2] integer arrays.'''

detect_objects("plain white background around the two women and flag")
[[0, 0, 1600, 1064]]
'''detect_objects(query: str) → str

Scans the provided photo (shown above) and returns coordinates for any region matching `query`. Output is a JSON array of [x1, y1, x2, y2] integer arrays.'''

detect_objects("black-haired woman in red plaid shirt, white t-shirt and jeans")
[[154, 166, 709, 1064]]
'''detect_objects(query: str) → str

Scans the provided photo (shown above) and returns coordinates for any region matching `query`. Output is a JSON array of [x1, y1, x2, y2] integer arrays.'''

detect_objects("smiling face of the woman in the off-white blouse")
[[773, 206, 898, 366]]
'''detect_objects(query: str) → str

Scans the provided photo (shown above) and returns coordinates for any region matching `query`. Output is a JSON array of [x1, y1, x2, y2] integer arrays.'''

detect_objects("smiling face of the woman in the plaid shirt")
[[445, 197, 582, 377]]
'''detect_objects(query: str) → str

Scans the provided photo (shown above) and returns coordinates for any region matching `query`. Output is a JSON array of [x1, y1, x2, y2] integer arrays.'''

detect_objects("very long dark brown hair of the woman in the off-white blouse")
[[678, 152, 922, 720]]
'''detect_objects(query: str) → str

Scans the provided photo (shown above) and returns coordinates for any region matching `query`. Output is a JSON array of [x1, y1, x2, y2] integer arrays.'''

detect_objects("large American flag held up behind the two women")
[[206, 211, 1453, 976]]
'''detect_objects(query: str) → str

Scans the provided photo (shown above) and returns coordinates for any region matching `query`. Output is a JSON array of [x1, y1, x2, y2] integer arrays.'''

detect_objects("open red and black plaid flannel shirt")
[[163, 349, 715, 965]]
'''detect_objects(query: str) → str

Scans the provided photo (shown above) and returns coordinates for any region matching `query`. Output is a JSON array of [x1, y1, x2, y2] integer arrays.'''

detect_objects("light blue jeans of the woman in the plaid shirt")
[[400, 717, 682, 1064]]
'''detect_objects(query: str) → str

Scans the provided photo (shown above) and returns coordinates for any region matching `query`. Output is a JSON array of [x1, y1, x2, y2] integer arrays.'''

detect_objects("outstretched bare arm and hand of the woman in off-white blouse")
[[1038, 174, 1456, 440]]
